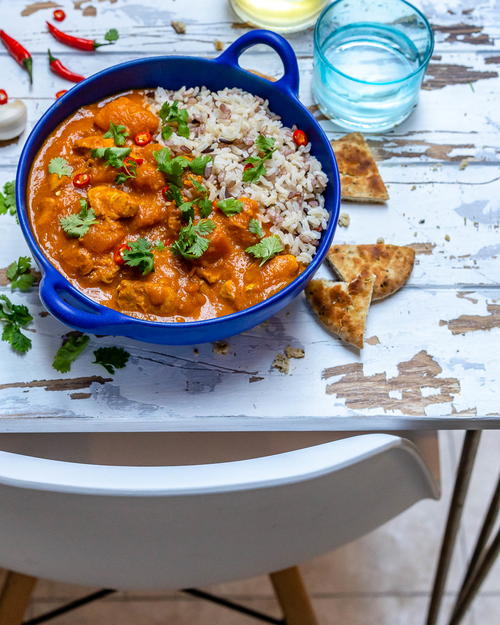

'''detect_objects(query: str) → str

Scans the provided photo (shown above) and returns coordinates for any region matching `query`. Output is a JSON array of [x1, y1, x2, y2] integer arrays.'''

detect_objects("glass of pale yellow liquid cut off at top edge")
[[229, 0, 328, 33]]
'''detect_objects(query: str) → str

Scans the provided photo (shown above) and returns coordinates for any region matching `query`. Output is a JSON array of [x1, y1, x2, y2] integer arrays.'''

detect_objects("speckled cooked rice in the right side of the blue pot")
[[151, 87, 329, 264]]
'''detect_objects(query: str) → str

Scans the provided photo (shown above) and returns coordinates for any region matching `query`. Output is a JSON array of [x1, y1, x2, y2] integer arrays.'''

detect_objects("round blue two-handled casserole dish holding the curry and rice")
[[16, 30, 340, 345]]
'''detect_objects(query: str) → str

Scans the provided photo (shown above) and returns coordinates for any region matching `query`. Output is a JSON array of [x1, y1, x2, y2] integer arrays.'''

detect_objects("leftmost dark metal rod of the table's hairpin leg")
[[426, 430, 481, 625]]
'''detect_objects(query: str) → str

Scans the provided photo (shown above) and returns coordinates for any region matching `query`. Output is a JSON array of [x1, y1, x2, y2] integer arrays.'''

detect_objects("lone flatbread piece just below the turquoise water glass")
[[332, 132, 389, 202]]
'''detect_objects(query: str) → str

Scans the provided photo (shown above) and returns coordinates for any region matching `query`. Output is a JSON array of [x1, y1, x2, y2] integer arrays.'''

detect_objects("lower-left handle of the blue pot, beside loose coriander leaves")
[[39, 273, 123, 334]]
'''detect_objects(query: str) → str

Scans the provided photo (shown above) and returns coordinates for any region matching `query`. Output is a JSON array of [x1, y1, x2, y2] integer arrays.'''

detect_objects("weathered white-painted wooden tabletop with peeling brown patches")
[[0, 0, 500, 431]]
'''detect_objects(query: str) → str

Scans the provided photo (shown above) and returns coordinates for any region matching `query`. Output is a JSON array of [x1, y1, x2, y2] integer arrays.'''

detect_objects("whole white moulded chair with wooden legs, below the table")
[[0, 433, 439, 625]]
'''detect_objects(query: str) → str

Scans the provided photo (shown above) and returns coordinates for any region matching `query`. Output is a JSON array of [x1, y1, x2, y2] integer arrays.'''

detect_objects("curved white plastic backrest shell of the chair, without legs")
[[0, 434, 437, 589]]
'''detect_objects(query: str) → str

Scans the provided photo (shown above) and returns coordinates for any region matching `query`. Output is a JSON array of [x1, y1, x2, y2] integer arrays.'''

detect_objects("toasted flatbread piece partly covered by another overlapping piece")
[[326, 243, 415, 300]]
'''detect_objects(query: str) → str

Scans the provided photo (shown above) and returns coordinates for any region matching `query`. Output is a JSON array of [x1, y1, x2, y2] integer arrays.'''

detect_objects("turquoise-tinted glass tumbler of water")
[[313, 0, 434, 132]]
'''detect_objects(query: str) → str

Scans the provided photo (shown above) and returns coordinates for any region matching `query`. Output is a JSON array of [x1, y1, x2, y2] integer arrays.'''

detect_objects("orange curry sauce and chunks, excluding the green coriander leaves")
[[28, 91, 303, 321]]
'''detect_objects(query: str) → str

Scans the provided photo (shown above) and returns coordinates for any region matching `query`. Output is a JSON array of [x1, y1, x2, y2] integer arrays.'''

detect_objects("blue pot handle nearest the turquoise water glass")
[[215, 29, 299, 97]]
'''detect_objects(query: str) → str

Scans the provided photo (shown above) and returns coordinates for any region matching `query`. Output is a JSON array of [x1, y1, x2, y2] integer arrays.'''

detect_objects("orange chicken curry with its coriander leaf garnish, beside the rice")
[[29, 91, 303, 322]]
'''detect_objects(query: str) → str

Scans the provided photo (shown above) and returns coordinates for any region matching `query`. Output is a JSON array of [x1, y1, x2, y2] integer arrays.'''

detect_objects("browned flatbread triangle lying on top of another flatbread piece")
[[306, 272, 375, 349]]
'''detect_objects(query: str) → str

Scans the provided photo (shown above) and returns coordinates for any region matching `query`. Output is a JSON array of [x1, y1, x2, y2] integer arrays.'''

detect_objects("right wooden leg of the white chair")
[[270, 566, 319, 625]]
